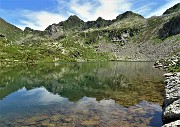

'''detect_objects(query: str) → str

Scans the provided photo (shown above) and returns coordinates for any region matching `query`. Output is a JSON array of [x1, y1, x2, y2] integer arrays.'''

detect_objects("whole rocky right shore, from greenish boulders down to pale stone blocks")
[[155, 53, 180, 127]]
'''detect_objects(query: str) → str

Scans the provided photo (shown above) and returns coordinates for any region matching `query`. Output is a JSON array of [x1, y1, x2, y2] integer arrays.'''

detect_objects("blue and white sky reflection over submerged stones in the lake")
[[0, 87, 162, 127]]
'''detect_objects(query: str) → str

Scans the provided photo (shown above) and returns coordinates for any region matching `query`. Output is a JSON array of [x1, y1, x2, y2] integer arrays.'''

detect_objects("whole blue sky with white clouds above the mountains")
[[0, 0, 180, 30]]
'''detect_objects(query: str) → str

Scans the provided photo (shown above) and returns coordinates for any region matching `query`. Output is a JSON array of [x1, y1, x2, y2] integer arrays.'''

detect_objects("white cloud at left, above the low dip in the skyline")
[[18, 10, 65, 30]]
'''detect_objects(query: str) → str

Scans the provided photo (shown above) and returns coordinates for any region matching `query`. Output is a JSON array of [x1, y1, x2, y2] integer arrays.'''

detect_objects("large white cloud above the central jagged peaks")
[[69, 0, 131, 21]]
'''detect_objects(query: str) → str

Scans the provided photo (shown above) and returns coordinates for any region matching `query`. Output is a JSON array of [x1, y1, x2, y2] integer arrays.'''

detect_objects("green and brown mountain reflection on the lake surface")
[[0, 62, 163, 106]]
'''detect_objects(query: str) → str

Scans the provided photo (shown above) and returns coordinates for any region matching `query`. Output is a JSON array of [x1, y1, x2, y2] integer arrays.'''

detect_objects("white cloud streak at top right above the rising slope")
[[146, 0, 180, 18]]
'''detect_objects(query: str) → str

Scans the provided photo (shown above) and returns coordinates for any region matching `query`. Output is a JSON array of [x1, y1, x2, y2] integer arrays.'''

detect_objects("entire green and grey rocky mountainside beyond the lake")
[[0, 4, 180, 62]]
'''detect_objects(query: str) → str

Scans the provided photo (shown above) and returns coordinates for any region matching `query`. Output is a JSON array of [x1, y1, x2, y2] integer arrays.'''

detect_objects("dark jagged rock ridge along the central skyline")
[[45, 11, 144, 35]]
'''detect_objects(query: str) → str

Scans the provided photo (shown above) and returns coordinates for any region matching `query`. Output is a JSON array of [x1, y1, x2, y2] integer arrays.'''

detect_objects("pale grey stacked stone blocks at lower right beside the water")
[[162, 72, 180, 127]]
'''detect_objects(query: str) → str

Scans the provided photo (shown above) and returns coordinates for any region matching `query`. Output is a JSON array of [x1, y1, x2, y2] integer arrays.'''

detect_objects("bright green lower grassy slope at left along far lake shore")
[[0, 34, 109, 63]]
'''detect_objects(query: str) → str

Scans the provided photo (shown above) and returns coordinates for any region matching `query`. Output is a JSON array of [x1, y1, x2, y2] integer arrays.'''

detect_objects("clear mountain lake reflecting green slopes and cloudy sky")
[[0, 62, 163, 127]]
